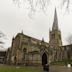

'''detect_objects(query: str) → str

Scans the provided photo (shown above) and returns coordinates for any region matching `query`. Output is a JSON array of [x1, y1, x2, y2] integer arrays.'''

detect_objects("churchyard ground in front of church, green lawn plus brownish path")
[[0, 64, 72, 72]]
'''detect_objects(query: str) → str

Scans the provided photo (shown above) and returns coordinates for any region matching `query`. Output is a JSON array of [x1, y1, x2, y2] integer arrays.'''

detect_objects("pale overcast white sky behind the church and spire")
[[0, 0, 72, 49]]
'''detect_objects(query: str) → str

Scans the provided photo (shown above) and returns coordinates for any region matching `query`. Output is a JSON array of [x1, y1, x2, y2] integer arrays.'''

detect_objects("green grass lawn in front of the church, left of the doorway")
[[0, 65, 43, 72]]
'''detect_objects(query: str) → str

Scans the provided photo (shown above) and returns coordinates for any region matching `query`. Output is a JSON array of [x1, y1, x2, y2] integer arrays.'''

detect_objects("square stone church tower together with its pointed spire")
[[49, 9, 62, 48]]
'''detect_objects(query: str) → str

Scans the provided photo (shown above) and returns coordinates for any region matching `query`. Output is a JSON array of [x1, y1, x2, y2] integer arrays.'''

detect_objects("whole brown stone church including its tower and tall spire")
[[6, 9, 72, 66]]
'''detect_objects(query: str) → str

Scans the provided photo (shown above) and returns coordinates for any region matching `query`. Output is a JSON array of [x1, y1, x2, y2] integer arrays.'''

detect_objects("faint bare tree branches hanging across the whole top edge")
[[13, 0, 72, 12]]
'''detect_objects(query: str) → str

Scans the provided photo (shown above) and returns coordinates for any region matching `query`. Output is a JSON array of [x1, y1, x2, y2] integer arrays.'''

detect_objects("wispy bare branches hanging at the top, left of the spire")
[[13, 0, 50, 14]]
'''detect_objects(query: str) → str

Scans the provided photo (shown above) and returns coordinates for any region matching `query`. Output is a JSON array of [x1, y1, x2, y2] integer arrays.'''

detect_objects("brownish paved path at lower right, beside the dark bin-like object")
[[50, 66, 72, 72]]
